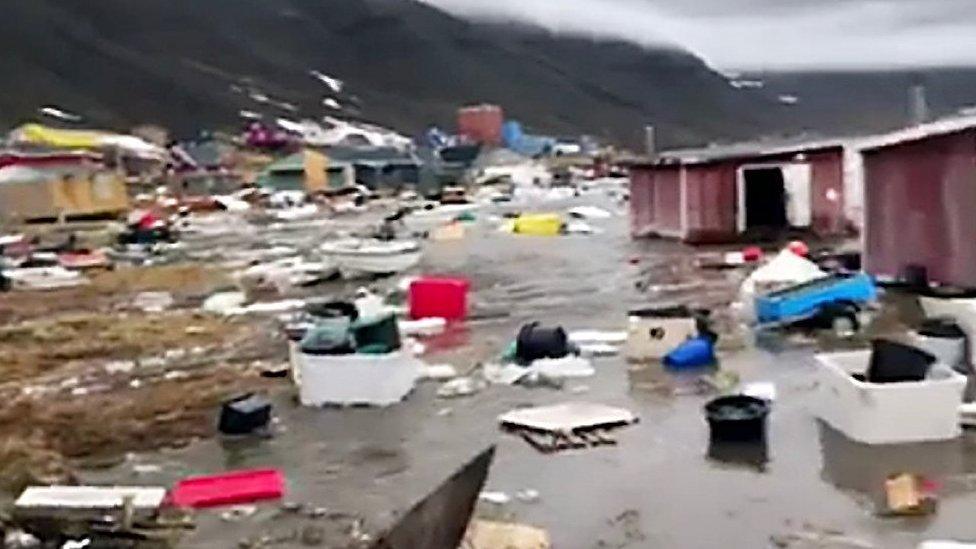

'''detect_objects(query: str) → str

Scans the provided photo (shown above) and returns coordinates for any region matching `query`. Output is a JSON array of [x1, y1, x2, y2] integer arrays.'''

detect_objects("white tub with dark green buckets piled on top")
[[296, 350, 422, 406]]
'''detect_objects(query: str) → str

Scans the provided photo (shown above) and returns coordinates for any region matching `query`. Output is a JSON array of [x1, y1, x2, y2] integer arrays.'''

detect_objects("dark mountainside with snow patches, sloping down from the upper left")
[[0, 0, 780, 146]]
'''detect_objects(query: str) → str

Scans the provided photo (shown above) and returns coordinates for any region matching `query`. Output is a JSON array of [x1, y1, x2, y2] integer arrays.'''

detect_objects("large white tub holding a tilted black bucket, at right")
[[815, 350, 966, 444]]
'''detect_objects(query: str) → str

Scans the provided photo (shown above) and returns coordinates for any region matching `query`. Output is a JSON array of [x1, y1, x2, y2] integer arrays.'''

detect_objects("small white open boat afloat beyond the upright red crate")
[[320, 238, 421, 278]]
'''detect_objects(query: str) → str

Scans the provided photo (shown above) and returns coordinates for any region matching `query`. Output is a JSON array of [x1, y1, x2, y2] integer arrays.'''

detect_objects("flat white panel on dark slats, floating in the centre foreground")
[[498, 402, 637, 433]]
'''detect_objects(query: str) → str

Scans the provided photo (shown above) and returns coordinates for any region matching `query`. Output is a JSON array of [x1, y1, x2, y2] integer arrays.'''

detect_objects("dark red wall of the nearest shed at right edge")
[[864, 131, 976, 287]]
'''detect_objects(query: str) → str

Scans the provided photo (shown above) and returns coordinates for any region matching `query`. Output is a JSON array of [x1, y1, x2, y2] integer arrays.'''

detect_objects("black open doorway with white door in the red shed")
[[736, 163, 812, 232]]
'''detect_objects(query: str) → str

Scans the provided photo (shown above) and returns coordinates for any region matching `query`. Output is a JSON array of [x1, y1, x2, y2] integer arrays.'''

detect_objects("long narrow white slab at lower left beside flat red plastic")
[[14, 486, 166, 512]]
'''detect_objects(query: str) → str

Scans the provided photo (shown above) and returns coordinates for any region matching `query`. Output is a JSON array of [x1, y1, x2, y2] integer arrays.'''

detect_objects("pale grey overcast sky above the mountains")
[[421, 0, 976, 69]]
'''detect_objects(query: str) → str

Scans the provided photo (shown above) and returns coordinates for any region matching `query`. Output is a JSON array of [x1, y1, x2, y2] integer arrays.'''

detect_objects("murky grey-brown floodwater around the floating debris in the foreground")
[[70, 198, 976, 549]]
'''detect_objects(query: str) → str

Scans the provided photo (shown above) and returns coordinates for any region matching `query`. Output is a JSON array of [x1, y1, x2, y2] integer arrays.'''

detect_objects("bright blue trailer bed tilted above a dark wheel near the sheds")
[[756, 274, 878, 323]]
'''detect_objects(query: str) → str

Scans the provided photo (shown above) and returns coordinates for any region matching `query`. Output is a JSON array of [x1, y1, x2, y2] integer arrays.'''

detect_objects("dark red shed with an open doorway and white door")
[[630, 140, 862, 243]]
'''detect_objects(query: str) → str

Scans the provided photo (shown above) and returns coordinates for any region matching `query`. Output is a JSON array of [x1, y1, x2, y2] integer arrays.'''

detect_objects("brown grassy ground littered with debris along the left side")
[[0, 265, 284, 493]]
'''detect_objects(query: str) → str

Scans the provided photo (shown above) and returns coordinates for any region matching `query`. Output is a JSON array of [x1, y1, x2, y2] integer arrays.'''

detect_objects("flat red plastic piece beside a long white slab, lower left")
[[169, 469, 285, 508]]
